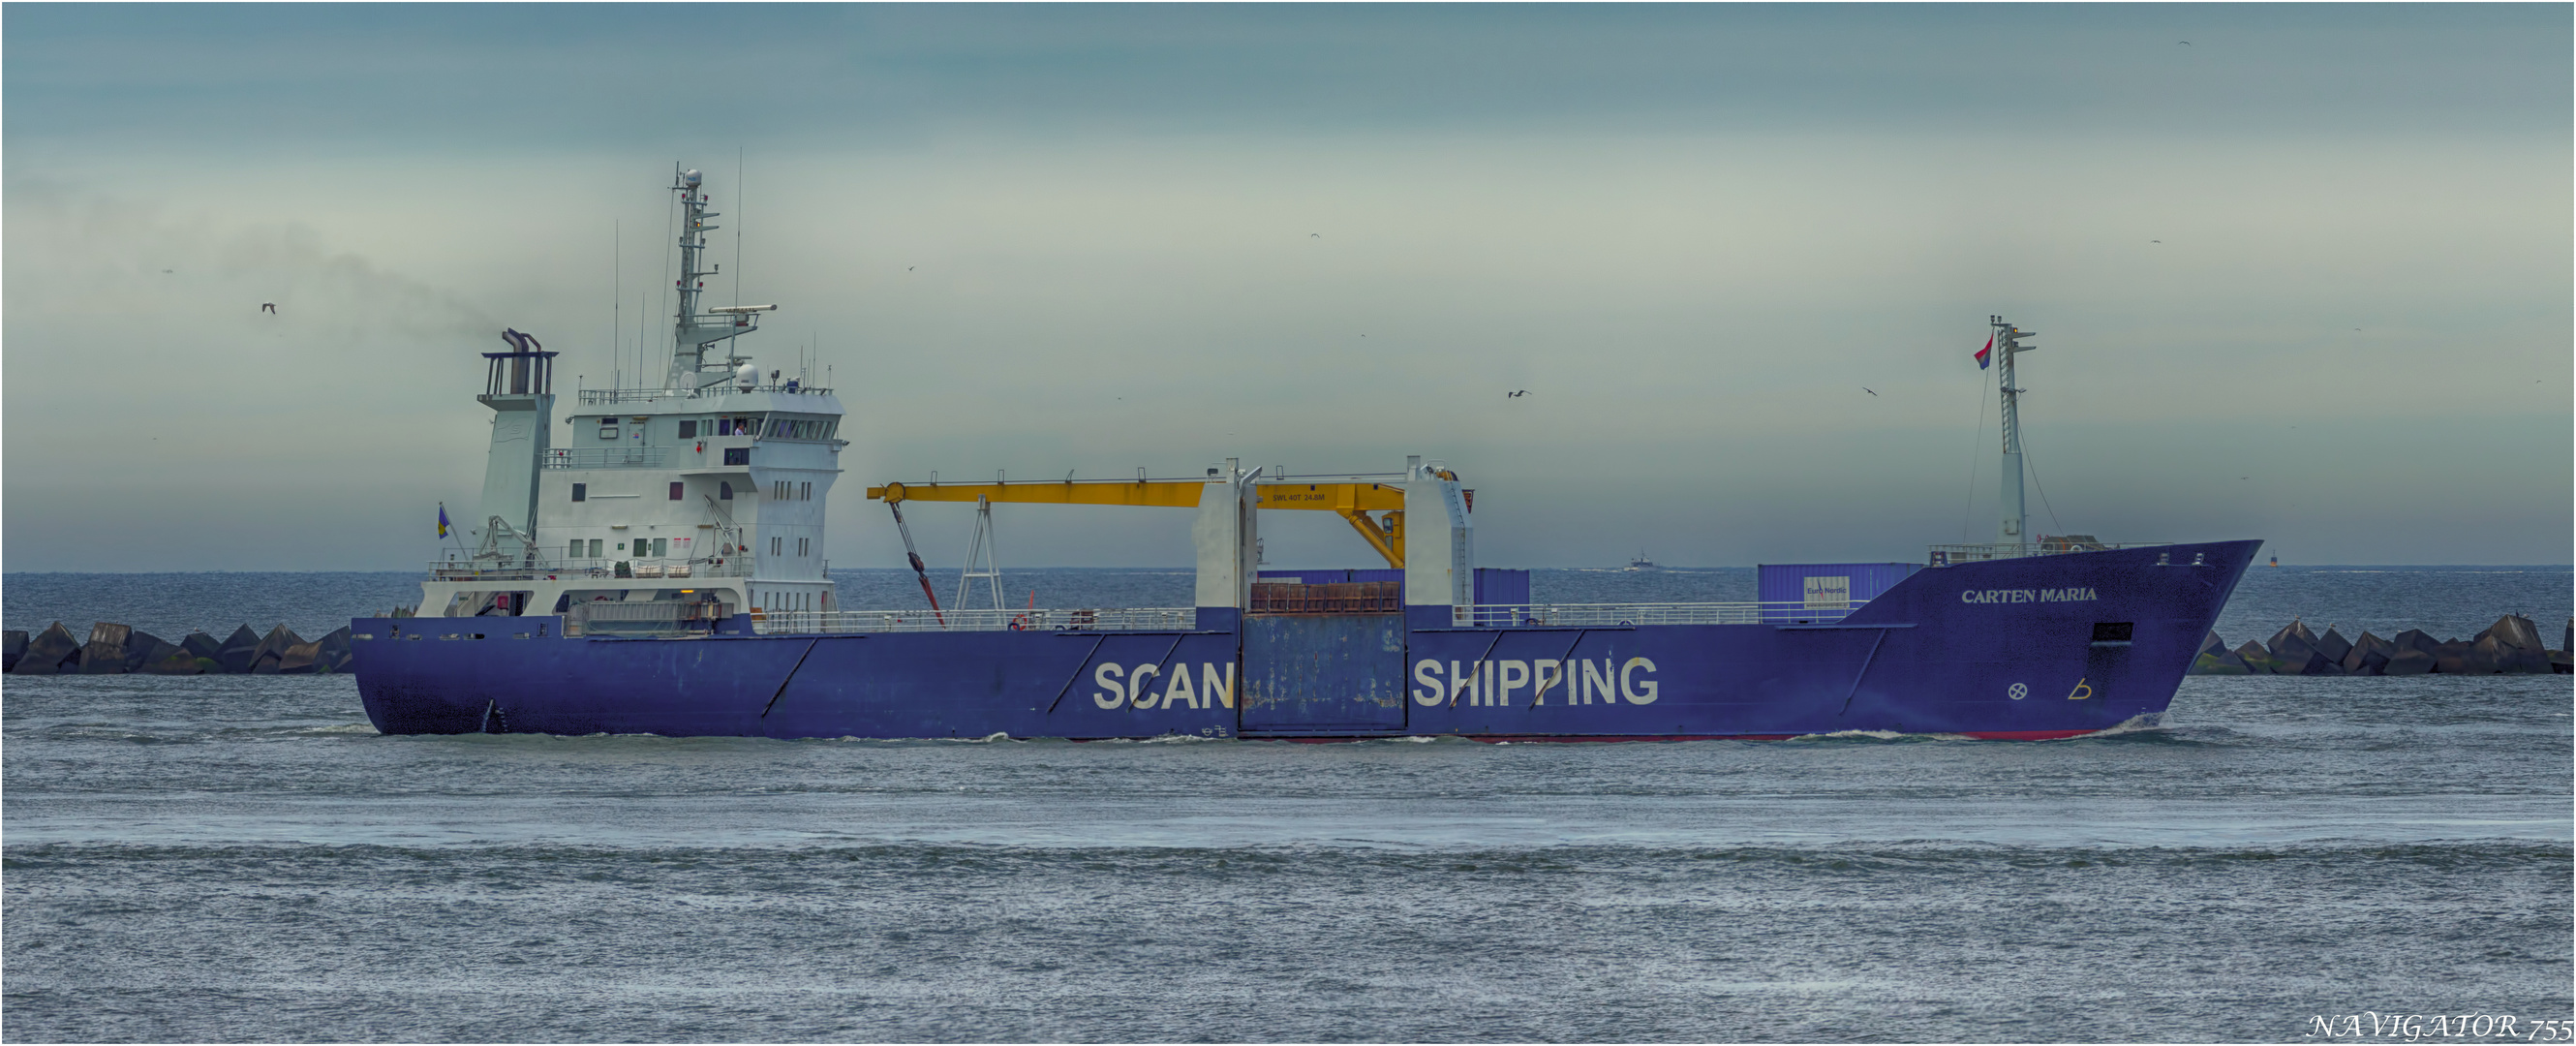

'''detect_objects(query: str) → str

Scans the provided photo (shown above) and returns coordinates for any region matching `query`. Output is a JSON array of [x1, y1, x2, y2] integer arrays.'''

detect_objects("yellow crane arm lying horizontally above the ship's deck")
[[868, 469, 1458, 569]]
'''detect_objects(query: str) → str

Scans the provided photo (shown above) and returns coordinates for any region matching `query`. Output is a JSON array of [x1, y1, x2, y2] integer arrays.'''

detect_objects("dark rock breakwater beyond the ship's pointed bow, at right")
[[2193, 613, 2576, 675]]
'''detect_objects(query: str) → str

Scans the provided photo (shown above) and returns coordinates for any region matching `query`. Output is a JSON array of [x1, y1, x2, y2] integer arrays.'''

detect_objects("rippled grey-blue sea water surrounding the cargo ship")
[[0, 567, 2576, 1041]]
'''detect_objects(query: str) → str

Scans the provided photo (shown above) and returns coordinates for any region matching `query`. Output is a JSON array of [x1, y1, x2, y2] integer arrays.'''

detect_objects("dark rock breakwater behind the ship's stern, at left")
[[0, 621, 355, 675]]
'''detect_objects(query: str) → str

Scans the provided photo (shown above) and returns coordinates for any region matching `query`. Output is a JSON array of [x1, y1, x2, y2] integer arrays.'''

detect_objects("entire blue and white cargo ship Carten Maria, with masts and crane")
[[351, 170, 2259, 742]]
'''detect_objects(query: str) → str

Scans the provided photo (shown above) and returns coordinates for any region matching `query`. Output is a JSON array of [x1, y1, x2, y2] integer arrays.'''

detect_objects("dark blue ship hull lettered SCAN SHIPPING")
[[351, 541, 2259, 739]]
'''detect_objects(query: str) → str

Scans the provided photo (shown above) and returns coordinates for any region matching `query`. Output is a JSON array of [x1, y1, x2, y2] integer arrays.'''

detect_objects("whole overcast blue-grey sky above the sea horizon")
[[0, 3, 2576, 569]]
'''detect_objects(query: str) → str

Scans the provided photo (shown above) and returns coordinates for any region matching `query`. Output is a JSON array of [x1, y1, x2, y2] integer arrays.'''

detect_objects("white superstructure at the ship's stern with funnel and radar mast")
[[417, 170, 847, 626]]
